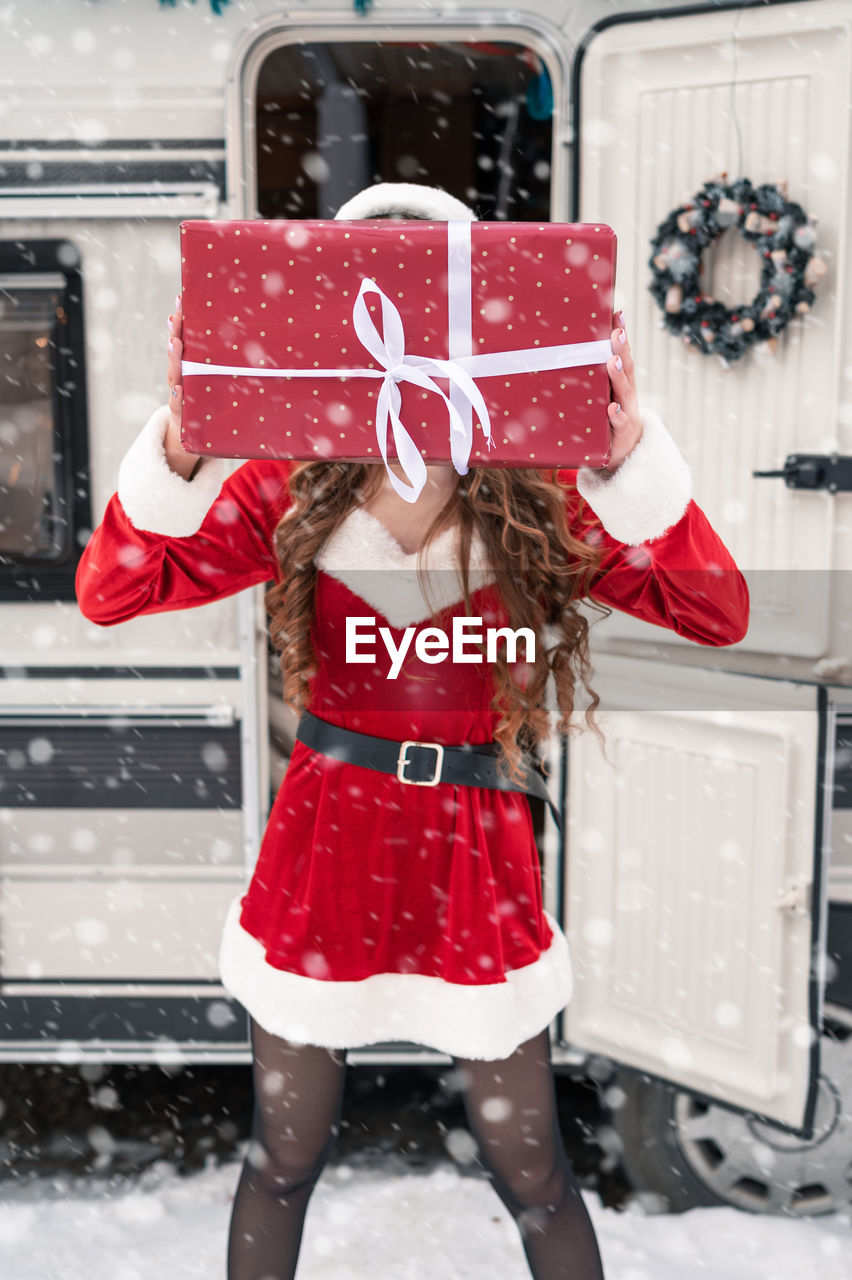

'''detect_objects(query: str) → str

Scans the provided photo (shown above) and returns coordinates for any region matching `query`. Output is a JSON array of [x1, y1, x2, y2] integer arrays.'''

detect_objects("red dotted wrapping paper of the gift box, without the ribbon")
[[180, 219, 615, 467]]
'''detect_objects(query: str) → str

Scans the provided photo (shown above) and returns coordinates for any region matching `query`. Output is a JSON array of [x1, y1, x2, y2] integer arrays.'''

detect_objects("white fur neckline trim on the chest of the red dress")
[[315, 507, 494, 627]]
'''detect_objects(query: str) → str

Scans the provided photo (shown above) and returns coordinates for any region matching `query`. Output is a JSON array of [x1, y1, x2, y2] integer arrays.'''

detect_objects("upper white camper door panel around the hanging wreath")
[[574, 0, 852, 657]]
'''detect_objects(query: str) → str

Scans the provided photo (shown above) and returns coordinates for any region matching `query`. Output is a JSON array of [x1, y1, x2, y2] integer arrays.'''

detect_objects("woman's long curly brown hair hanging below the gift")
[[266, 462, 610, 782]]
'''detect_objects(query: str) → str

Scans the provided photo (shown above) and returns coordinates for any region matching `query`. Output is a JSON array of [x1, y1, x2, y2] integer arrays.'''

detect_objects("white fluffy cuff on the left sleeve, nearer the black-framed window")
[[118, 404, 226, 538]]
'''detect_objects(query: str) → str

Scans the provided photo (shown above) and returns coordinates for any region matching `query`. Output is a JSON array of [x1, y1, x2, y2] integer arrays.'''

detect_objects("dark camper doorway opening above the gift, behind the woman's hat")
[[256, 41, 553, 221]]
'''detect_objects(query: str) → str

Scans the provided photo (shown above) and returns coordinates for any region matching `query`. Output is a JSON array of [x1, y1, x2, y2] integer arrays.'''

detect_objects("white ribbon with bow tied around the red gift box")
[[180, 220, 611, 502]]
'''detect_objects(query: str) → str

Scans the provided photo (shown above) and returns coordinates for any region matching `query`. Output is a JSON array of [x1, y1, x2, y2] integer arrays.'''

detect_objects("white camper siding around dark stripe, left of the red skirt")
[[0, 680, 263, 983]]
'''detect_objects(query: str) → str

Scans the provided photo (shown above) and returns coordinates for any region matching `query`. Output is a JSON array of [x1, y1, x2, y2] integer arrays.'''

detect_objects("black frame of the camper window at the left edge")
[[0, 237, 92, 604]]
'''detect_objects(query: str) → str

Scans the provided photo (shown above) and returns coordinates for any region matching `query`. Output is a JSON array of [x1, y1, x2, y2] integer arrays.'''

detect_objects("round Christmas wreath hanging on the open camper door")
[[647, 173, 826, 369]]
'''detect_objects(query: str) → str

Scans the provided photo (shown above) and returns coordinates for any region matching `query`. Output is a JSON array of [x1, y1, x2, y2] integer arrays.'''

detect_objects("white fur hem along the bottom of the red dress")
[[219, 896, 573, 1060]]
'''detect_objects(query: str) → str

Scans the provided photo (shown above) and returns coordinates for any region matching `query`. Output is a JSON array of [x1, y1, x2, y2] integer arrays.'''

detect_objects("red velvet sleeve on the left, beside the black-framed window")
[[77, 461, 289, 626]]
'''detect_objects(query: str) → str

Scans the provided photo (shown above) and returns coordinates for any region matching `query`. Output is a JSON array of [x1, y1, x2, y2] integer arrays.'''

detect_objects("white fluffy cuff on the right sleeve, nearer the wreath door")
[[577, 408, 692, 547]]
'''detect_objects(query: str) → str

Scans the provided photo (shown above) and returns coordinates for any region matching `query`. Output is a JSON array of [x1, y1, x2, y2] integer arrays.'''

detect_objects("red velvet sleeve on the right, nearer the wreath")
[[560, 471, 748, 645]]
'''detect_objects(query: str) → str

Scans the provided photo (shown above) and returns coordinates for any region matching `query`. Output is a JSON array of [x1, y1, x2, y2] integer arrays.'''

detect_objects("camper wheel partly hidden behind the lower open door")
[[611, 1005, 852, 1217]]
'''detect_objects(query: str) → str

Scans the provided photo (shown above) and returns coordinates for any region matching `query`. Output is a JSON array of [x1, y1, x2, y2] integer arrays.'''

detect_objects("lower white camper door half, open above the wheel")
[[562, 655, 824, 1129]]
